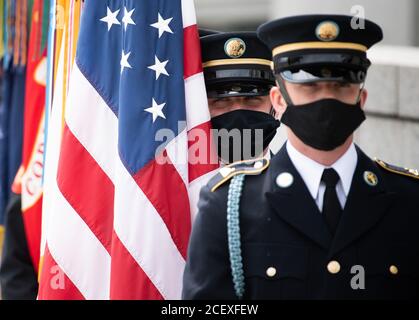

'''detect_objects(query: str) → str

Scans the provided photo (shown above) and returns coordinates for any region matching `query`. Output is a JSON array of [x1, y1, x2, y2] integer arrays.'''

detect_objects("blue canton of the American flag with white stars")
[[76, 0, 186, 174]]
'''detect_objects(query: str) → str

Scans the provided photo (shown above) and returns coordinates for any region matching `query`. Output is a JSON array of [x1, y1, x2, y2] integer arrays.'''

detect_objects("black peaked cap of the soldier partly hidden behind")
[[201, 32, 275, 98]]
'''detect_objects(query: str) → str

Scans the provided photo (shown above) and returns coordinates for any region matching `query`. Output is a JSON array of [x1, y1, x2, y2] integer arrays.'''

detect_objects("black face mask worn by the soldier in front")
[[281, 99, 365, 151]]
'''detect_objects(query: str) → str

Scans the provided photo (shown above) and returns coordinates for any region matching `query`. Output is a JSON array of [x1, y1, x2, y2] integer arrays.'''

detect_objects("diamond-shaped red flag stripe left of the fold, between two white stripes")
[[57, 126, 114, 254]]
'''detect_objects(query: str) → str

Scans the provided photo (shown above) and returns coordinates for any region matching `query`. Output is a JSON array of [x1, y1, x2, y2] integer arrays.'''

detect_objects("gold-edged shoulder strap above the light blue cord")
[[208, 158, 269, 192]]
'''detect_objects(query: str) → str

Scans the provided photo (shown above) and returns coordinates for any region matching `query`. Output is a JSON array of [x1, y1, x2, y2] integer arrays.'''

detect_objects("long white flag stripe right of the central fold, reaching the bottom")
[[114, 161, 185, 299]]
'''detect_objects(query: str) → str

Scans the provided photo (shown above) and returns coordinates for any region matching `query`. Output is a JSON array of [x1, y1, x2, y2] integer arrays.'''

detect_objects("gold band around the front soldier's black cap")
[[272, 41, 367, 56]]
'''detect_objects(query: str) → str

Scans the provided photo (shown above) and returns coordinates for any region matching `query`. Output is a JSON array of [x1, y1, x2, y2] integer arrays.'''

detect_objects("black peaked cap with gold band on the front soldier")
[[257, 15, 383, 83]]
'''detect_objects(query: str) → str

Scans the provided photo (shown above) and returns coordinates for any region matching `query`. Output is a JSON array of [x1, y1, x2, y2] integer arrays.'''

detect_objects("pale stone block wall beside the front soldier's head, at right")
[[356, 47, 419, 168]]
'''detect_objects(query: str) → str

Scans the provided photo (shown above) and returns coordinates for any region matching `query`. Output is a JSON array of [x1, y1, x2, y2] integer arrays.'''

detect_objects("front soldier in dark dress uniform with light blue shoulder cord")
[[183, 15, 419, 299]]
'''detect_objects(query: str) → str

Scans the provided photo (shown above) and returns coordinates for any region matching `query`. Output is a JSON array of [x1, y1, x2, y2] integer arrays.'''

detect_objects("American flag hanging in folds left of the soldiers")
[[39, 0, 218, 299]]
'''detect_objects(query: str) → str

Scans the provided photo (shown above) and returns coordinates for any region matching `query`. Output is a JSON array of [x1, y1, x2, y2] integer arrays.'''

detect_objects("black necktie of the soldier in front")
[[322, 168, 342, 234]]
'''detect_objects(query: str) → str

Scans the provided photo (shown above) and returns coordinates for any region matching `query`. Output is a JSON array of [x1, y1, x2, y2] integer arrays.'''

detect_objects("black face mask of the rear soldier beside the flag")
[[211, 109, 280, 163]]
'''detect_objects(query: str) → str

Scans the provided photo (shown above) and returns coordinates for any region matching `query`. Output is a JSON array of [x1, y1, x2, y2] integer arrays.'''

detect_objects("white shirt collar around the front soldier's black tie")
[[286, 141, 358, 199]]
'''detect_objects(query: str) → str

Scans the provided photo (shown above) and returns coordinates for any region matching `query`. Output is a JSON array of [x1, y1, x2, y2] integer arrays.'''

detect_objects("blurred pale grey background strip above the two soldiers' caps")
[[195, 0, 419, 46]]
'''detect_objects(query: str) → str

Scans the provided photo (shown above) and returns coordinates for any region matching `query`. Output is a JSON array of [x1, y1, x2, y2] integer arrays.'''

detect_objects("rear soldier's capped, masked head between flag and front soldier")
[[200, 32, 279, 163]]
